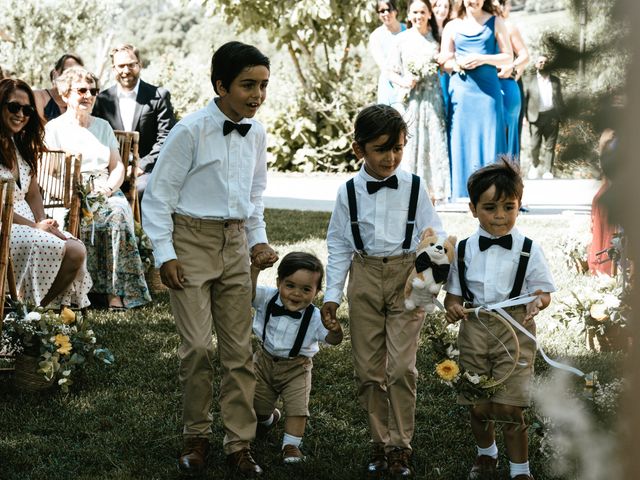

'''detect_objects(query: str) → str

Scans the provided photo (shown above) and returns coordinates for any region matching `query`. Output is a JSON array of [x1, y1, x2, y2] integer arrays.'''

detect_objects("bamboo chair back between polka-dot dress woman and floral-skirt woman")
[[38, 150, 82, 237]]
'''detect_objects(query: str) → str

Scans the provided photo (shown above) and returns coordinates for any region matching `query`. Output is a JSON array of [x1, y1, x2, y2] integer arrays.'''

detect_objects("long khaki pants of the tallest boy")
[[170, 214, 256, 454]]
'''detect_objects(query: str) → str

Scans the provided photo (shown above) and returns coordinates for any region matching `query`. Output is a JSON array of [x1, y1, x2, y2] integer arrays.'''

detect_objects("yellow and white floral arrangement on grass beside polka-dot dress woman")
[[0, 302, 114, 392]]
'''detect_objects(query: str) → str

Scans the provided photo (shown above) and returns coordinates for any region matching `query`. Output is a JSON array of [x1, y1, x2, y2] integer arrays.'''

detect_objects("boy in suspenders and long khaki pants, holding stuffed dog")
[[322, 105, 444, 477]]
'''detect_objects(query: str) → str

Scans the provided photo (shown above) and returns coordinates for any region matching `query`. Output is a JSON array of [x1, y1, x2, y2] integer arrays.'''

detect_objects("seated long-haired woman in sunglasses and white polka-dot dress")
[[0, 78, 91, 308]]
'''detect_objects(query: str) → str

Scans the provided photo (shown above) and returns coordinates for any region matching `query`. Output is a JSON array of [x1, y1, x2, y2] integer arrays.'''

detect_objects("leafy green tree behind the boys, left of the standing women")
[[205, 0, 375, 170]]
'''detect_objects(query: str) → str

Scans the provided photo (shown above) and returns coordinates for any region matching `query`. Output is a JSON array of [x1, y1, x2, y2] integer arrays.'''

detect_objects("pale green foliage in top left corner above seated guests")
[[0, 0, 112, 86]]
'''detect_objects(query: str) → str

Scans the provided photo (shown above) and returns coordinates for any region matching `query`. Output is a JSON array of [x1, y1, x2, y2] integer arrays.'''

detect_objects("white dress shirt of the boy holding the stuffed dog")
[[324, 165, 445, 303]]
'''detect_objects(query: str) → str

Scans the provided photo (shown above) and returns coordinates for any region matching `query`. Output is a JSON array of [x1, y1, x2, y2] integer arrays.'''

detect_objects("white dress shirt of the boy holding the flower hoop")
[[445, 227, 556, 305]]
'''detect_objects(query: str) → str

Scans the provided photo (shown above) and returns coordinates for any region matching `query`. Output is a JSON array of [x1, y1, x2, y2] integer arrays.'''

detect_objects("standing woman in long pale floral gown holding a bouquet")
[[390, 0, 450, 202]]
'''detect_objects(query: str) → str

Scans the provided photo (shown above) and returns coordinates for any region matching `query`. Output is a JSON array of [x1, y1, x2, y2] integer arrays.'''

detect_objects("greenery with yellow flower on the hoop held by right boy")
[[425, 315, 502, 400]]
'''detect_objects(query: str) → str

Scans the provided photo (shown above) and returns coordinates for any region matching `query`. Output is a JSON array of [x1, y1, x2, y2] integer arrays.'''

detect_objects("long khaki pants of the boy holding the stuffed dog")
[[347, 254, 424, 451]]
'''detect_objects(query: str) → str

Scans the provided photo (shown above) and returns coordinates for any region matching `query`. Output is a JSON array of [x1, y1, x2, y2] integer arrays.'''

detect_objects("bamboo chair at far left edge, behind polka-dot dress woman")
[[0, 177, 18, 346]]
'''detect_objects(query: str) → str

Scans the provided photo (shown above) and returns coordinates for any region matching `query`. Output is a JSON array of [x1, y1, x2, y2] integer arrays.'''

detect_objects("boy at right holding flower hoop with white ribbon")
[[445, 158, 555, 480]]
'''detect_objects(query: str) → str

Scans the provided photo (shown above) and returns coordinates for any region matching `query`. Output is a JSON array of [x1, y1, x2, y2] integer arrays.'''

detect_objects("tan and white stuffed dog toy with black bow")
[[404, 227, 456, 313]]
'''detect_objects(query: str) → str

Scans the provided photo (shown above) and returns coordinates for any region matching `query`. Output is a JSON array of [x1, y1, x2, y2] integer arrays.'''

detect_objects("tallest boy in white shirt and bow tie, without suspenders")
[[143, 42, 277, 477]]
